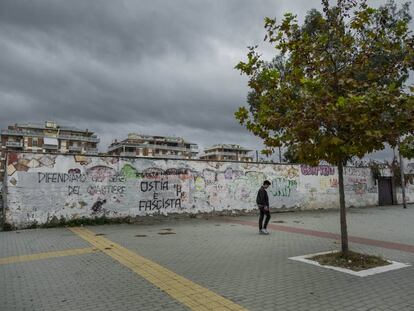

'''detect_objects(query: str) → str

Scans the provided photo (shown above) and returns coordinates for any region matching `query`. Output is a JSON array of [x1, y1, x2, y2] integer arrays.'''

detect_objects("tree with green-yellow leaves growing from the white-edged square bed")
[[235, 0, 414, 256]]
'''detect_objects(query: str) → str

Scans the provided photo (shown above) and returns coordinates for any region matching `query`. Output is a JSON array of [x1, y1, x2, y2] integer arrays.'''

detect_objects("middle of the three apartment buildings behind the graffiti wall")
[[108, 133, 198, 159]]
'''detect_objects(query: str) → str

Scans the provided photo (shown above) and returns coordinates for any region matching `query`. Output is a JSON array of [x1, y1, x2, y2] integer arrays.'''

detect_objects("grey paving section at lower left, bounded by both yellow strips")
[[0, 253, 188, 311]]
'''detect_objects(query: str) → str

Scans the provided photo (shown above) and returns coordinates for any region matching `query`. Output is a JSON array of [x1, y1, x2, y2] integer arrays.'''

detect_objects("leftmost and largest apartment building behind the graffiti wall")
[[0, 121, 99, 177]]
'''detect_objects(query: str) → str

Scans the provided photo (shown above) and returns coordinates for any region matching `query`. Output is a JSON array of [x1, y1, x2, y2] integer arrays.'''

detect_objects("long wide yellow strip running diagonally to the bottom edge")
[[69, 228, 246, 311]]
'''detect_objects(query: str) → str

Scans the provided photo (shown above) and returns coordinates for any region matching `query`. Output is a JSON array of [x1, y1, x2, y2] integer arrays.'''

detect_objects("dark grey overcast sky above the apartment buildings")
[[0, 0, 413, 161]]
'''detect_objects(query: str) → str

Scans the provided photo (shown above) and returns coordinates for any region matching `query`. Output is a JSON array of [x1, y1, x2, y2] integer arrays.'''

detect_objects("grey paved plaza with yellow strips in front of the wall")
[[0, 205, 414, 311]]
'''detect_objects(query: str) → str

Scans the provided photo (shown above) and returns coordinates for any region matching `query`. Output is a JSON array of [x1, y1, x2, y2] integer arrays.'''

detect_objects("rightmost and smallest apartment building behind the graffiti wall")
[[200, 144, 253, 162]]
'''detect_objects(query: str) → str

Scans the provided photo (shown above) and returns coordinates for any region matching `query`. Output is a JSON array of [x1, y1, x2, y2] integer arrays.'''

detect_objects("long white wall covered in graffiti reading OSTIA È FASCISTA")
[[1, 153, 414, 227]]
